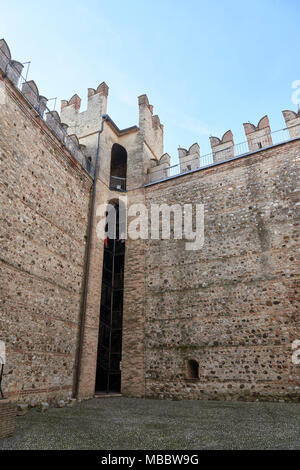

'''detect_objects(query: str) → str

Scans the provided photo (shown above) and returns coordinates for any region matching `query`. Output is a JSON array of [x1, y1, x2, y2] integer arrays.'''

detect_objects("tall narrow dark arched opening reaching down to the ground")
[[96, 201, 125, 393]]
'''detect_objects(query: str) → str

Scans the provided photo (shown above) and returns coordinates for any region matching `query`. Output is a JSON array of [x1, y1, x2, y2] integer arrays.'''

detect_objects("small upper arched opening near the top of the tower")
[[110, 144, 127, 191]]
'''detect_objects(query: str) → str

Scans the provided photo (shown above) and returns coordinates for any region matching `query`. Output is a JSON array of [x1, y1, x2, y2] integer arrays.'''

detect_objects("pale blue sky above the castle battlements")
[[0, 0, 300, 162]]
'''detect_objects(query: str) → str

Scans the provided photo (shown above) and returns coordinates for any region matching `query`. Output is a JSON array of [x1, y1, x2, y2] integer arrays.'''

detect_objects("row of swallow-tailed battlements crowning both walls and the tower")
[[0, 39, 300, 187]]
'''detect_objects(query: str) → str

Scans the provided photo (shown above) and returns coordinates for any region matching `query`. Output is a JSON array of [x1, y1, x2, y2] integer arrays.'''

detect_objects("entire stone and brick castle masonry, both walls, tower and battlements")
[[0, 40, 300, 405]]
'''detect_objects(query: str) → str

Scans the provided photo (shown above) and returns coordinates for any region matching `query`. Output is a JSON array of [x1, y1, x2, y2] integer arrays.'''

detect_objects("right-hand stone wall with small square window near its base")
[[145, 140, 300, 400]]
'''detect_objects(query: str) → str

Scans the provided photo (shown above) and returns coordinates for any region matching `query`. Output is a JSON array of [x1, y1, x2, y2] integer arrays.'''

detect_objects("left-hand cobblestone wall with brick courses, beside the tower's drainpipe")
[[0, 73, 92, 402]]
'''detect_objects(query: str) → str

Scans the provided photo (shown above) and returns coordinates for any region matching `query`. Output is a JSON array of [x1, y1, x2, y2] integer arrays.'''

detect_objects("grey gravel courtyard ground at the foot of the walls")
[[0, 398, 300, 450]]
